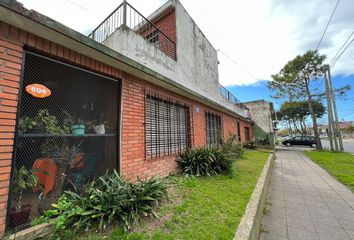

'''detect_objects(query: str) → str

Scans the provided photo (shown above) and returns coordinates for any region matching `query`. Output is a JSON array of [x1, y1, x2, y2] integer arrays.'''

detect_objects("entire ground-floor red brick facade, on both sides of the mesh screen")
[[0, 20, 252, 235]]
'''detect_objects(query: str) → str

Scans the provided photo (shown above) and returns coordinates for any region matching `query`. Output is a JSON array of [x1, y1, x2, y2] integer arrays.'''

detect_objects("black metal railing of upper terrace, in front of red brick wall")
[[89, 1, 176, 59]]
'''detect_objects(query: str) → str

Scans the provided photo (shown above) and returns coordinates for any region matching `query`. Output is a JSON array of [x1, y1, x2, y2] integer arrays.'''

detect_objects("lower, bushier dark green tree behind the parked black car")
[[277, 101, 326, 134]]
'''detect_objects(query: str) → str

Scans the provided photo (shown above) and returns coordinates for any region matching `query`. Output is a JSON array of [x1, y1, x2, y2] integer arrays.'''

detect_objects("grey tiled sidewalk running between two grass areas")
[[260, 150, 354, 240]]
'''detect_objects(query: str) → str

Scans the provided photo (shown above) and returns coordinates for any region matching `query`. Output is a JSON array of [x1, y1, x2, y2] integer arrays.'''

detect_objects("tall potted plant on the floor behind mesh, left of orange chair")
[[10, 166, 39, 228]]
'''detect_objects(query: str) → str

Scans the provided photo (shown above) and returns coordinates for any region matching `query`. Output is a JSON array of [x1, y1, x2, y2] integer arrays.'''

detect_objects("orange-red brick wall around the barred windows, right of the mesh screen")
[[121, 75, 251, 179]]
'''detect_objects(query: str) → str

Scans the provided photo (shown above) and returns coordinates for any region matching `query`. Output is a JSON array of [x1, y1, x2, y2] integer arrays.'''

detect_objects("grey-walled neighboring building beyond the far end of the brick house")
[[244, 99, 277, 145]]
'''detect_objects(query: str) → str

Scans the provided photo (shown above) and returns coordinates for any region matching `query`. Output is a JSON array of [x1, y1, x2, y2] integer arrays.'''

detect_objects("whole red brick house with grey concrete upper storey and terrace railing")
[[0, 0, 254, 235]]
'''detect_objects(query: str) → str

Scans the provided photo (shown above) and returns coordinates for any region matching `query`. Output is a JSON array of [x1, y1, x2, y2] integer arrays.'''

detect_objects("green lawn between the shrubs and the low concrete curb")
[[81, 151, 269, 240]]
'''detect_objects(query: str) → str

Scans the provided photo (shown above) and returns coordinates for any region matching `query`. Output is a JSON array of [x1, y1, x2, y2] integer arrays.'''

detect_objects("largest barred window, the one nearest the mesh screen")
[[145, 95, 190, 158]]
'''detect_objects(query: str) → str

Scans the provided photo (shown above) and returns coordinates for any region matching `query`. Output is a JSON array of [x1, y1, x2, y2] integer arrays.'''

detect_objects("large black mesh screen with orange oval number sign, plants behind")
[[8, 52, 119, 230]]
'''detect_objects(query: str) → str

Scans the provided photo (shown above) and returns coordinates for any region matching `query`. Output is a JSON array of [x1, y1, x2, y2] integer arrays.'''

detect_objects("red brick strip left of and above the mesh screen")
[[0, 22, 123, 238]]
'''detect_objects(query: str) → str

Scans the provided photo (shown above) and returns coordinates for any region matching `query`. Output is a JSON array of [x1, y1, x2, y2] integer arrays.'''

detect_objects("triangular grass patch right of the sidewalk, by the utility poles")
[[305, 151, 354, 192]]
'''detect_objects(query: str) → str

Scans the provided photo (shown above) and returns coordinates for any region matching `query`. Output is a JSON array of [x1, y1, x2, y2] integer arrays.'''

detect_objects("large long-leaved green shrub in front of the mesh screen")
[[32, 171, 167, 232]]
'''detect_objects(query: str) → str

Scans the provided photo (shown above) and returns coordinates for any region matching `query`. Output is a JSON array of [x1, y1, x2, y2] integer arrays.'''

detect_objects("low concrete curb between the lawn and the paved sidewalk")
[[234, 152, 275, 240]]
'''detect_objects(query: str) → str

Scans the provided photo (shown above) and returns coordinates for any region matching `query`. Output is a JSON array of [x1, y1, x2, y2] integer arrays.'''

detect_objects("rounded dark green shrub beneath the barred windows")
[[176, 147, 235, 176]]
